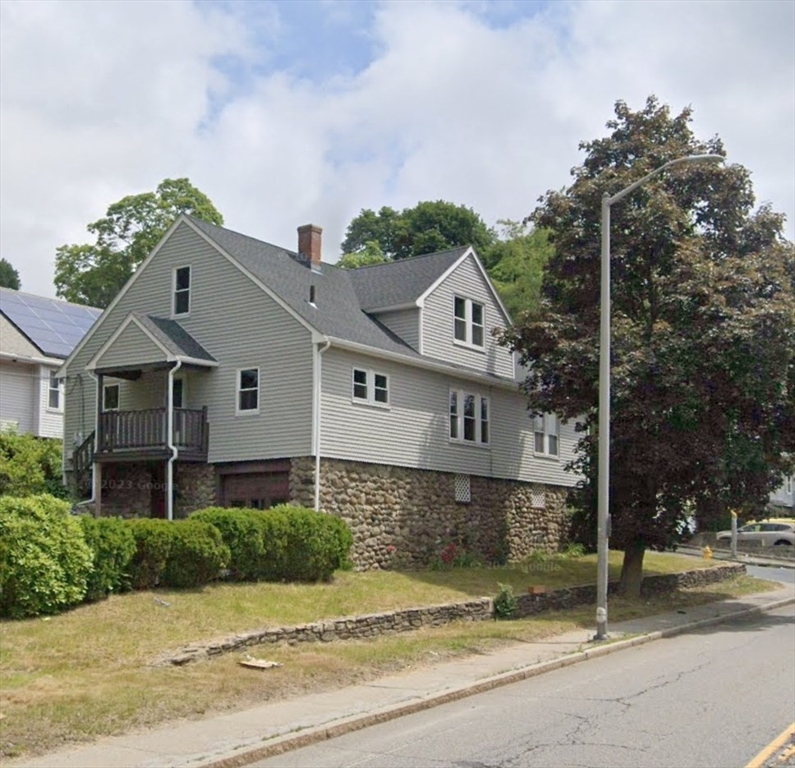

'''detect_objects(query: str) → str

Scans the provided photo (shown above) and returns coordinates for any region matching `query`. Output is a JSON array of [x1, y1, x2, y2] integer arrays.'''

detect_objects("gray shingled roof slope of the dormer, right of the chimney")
[[350, 246, 471, 311]]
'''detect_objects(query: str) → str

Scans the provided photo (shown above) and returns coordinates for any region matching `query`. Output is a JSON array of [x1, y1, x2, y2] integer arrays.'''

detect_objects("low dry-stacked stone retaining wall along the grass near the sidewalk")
[[153, 563, 745, 666]]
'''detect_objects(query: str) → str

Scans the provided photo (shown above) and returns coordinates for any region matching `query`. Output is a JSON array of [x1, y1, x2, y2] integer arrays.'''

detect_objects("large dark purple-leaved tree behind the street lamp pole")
[[503, 97, 795, 594]]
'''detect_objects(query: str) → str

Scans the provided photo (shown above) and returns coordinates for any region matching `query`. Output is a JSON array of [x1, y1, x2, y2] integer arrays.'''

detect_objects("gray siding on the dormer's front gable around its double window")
[[422, 256, 514, 378]]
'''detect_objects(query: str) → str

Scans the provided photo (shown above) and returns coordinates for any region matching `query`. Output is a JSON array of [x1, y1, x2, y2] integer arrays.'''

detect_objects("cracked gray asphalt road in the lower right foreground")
[[256, 608, 795, 768]]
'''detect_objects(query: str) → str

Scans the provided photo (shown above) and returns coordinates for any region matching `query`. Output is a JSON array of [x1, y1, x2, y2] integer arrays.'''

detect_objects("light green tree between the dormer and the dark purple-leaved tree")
[[481, 219, 553, 321]]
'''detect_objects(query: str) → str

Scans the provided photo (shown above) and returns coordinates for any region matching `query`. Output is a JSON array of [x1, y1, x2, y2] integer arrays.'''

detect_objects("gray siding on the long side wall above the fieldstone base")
[[321, 347, 577, 485]]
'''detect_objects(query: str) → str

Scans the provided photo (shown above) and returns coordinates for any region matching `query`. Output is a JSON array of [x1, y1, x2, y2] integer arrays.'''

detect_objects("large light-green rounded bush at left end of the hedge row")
[[0, 494, 93, 618]]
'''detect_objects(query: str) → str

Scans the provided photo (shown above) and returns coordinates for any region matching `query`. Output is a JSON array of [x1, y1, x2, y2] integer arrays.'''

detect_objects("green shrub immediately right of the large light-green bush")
[[78, 515, 136, 601]]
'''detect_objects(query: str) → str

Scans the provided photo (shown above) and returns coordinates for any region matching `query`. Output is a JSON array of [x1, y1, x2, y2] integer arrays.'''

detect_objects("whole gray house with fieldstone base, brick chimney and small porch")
[[60, 216, 579, 567]]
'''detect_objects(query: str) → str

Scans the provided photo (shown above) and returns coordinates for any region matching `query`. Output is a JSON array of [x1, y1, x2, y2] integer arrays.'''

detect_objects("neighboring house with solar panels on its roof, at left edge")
[[0, 288, 101, 438]]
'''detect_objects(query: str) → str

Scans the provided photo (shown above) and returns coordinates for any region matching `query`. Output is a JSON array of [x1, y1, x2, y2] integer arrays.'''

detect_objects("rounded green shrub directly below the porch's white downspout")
[[162, 520, 229, 587]]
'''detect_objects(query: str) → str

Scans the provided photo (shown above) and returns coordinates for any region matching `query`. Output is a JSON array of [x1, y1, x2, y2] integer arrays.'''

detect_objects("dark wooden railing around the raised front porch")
[[96, 408, 209, 454]]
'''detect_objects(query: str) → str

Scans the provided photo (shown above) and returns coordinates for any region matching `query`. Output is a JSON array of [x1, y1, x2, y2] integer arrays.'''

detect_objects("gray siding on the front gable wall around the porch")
[[61, 219, 313, 462]]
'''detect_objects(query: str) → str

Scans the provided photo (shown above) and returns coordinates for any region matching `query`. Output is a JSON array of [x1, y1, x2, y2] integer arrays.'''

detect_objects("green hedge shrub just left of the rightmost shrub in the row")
[[190, 507, 265, 581]]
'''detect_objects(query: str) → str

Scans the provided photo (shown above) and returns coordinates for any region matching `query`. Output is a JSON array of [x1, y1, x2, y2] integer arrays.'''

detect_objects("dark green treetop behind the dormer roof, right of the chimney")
[[341, 200, 496, 260]]
